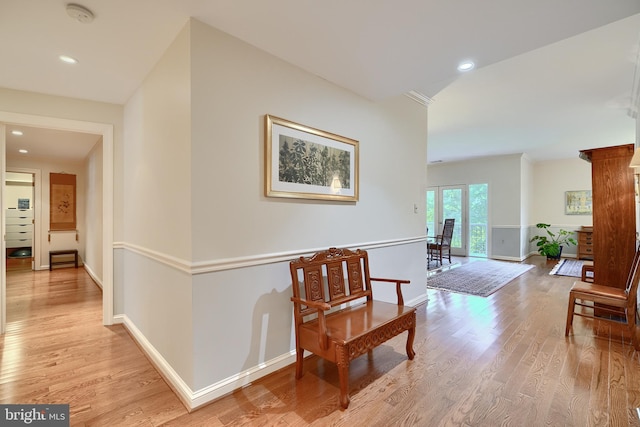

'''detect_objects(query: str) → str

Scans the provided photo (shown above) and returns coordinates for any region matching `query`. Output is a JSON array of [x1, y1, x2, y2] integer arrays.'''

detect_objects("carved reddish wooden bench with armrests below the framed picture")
[[290, 248, 416, 408]]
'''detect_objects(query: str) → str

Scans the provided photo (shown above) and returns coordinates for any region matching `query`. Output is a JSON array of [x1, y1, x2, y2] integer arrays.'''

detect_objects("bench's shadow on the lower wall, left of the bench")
[[243, 287, 293, 370]]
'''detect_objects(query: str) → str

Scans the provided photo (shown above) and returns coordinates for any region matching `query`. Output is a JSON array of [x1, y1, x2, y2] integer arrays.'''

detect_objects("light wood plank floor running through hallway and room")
[[0, 257, 640, 427]]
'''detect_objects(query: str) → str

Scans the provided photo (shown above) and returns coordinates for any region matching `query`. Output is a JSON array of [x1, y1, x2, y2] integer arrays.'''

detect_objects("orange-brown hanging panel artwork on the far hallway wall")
[[49, 173, 76, 230]]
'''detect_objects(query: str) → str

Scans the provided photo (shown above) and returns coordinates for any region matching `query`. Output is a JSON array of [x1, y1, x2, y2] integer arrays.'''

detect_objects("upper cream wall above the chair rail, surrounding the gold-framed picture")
[[191, 20, 426, 261]]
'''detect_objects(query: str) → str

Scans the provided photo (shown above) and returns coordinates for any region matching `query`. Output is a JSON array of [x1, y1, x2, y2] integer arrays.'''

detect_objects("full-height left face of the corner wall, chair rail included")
[[122, 21, 193, 385]]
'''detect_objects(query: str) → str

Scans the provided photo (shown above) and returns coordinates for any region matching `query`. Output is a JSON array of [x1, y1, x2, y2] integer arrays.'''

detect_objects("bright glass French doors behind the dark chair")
[[426, 184, 489, 257]]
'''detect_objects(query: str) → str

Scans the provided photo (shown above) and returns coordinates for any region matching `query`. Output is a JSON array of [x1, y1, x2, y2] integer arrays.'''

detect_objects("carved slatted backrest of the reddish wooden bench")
[[290, 248, 372, 317]]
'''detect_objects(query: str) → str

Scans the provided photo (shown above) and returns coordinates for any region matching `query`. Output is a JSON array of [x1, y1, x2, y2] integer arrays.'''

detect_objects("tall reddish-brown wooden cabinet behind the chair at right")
[[580, 144, 636, 288]]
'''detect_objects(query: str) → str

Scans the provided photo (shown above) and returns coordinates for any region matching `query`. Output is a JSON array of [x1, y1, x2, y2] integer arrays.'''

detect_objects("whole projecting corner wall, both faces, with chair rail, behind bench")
[[120, 20, 426, 408]]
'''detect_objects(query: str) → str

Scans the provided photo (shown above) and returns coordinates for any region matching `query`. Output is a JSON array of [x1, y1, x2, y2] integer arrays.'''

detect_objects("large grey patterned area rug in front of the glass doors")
[[427, 260, 533, 297]]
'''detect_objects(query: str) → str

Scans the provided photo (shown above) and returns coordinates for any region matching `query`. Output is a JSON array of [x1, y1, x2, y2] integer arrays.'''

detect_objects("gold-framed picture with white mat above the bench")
[[265, 115, 358, 202]]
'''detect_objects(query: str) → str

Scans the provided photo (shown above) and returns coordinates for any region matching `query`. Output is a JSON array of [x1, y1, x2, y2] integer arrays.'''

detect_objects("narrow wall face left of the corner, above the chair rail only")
[[124, 29, 191, 260]]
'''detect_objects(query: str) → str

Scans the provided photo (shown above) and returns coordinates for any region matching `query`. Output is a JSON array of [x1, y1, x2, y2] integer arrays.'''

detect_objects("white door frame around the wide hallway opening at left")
[[0, 111, 114, 334]]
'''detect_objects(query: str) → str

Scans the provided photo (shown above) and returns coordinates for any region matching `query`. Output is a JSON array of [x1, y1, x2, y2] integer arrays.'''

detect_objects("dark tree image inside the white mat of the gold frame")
[[278, 134, 351, 189]]
